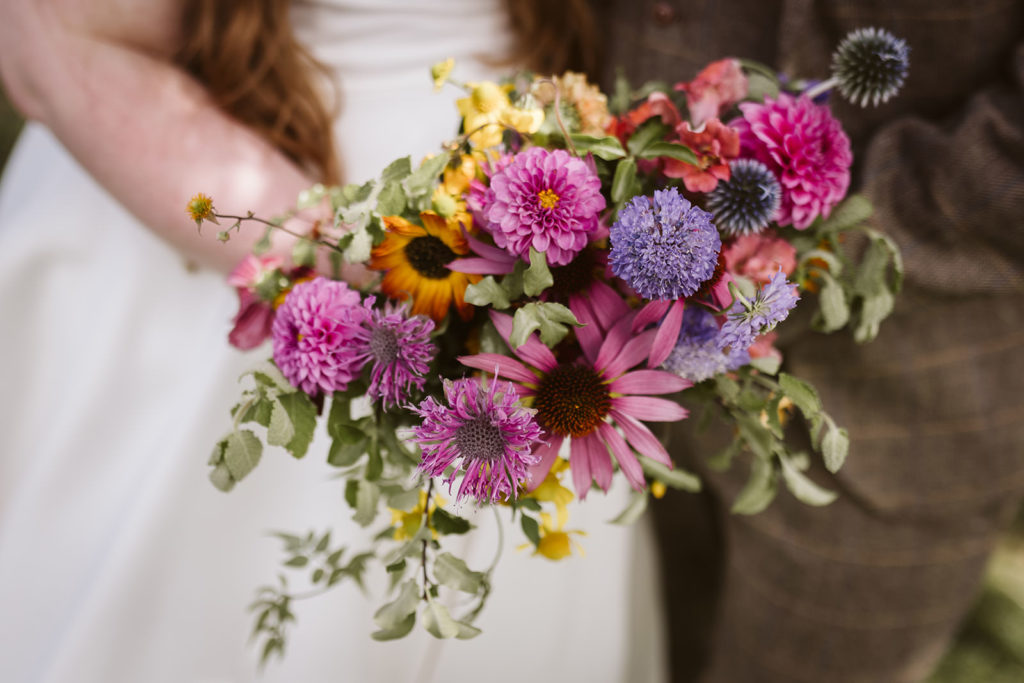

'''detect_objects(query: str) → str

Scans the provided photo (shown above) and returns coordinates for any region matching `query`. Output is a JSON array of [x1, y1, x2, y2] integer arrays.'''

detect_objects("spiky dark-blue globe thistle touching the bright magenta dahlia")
[[708, 159, 782, 236]]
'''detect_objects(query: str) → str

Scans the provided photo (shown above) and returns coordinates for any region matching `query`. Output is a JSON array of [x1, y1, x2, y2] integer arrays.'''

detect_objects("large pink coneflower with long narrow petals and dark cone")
[[460, 306, 690, 498]]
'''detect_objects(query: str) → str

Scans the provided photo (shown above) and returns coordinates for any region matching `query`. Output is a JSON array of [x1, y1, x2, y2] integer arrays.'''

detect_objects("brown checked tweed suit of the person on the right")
[[595, 0, 1024, 683]]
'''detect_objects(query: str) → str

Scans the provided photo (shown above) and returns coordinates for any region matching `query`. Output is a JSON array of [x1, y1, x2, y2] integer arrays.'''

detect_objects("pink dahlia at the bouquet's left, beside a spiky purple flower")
[[272, 278, 367, 395]]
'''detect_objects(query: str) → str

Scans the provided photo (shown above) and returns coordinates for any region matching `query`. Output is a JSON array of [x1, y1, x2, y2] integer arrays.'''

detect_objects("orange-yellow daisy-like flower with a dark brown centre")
[[370, 211, 480, 323]]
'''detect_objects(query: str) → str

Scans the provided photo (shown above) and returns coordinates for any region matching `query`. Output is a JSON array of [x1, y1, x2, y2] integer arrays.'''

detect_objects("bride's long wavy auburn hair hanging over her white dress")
[[175, 0, 599, 183]]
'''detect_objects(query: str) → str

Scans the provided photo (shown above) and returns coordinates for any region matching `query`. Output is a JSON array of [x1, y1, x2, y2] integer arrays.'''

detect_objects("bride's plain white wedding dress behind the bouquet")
[[0, 0, 664, 683]]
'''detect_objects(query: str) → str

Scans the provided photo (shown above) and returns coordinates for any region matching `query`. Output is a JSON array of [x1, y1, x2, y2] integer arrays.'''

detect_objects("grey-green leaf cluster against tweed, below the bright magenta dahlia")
[[788, 195, 903, 343]]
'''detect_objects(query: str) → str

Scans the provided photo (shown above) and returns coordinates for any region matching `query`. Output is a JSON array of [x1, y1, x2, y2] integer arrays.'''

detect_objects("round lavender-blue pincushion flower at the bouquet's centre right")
[[608, 187, 722, 300]]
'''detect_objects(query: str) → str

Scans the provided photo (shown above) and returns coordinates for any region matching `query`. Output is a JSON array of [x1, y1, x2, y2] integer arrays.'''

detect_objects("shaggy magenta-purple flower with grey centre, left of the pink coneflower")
[[412, 378, 541, 503]]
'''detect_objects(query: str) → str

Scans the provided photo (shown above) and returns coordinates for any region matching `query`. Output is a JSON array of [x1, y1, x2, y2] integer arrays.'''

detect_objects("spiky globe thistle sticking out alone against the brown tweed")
[[833, 28, 910, 106]]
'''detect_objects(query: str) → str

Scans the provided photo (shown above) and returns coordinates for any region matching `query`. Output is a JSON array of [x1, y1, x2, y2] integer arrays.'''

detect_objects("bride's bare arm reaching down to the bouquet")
[[0, 2, 323, 270]]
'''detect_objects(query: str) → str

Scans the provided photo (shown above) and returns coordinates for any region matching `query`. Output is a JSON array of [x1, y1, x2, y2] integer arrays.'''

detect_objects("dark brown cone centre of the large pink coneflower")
[[534, 365, 611, 436]]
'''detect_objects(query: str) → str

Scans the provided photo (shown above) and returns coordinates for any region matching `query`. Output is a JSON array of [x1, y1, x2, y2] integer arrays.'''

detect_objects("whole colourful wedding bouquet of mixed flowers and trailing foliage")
[[188, 29, 908, 658]]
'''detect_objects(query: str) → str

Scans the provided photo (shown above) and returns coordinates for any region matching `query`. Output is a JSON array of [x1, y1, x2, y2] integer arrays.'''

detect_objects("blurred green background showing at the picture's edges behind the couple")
[[0, 91, 1024, 683]]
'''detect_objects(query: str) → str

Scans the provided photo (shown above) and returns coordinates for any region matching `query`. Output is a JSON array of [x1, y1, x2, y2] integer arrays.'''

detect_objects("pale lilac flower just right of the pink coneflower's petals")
[[663, 306, 751, 383]]
